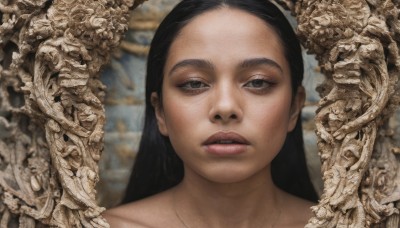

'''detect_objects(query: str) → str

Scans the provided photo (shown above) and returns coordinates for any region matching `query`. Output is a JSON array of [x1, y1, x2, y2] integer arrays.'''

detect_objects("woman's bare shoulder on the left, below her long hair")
[[103, 189, 177, 228]]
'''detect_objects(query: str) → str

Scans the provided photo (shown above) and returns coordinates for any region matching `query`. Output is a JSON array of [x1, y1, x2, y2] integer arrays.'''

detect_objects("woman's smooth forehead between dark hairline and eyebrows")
[[166, 7, 287, 74]]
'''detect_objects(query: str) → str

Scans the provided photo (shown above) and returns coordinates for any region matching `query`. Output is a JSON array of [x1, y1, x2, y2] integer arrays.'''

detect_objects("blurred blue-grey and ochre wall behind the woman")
[[97, 0, 324, 208]]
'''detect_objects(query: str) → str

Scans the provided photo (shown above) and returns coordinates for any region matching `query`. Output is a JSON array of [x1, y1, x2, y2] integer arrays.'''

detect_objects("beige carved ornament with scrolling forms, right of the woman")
[[276, 0, 400, 228]]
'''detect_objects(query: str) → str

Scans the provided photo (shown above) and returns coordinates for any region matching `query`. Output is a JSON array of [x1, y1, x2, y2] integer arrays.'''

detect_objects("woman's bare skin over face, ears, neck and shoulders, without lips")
[[104, 8, 312, 228]]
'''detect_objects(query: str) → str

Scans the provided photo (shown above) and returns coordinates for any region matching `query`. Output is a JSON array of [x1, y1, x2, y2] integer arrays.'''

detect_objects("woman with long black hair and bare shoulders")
[[105, 0, 316, 228]]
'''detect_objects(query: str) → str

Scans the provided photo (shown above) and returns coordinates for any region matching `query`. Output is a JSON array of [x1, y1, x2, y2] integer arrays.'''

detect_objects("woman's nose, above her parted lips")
[[209, 84, 243, 124]]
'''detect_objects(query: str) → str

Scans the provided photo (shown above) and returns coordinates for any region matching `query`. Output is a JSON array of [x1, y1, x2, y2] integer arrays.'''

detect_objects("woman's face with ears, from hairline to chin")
[[152, 8, 304, 183]]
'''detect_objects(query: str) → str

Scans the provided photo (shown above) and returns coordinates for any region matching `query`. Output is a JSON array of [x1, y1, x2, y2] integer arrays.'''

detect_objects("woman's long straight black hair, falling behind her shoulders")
[[122, 0, 318, 203]]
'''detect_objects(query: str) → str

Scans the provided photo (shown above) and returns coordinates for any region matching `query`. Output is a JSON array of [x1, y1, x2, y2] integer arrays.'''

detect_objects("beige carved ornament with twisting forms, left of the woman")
[[0, 0, 142, 228]]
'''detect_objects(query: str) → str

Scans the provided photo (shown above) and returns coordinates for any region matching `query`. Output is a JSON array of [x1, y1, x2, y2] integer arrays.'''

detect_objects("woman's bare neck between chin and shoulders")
[[174, 167, 280, 228]]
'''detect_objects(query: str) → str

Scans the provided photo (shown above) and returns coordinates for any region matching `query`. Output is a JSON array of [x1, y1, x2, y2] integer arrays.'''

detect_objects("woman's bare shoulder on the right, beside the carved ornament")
[[282, 192, 316, 228]]
